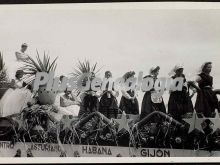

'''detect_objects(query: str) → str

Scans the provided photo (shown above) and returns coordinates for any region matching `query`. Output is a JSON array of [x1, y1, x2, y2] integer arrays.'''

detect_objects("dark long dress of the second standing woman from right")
[[168, 75, 193, 121]]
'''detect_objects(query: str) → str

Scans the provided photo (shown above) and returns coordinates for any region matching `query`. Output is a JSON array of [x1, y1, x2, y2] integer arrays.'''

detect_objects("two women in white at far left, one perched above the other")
[[0, 43, 33, 117]]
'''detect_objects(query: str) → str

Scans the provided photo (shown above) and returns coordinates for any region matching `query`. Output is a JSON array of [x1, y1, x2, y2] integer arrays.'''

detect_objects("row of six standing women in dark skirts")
[[67, 62, 219, 121]]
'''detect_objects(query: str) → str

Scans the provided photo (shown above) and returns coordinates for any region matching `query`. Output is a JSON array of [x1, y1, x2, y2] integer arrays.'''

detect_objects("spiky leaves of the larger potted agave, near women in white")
[[20, 51, 57, 83]]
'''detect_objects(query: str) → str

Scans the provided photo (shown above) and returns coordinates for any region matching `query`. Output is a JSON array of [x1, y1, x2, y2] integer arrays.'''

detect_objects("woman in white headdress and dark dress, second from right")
[[168, 65, 196, 121]]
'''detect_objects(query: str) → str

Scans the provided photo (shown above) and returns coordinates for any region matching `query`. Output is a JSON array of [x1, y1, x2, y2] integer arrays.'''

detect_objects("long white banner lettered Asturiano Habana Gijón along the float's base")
[[0, 141, 217, 157]]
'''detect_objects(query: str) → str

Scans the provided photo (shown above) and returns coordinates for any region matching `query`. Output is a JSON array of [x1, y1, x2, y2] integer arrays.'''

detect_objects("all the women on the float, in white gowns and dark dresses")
[[0, 44, 220, 120]]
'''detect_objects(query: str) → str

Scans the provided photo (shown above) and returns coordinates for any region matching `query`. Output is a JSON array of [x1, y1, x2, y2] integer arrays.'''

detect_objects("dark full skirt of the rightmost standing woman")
[[195, 88, 218, 117]]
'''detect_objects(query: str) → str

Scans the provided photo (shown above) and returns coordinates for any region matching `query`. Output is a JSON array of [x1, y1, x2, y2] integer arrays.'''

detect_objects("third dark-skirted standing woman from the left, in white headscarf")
[[119, 71, 139, 115]]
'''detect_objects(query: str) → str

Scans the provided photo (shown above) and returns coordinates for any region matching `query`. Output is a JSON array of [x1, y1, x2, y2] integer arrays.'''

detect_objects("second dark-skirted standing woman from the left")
[[99, 71, 118, 119]]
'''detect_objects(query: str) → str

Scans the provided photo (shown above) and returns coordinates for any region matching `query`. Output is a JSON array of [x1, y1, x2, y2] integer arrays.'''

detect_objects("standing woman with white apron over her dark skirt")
[[140, 66, 166, 119]]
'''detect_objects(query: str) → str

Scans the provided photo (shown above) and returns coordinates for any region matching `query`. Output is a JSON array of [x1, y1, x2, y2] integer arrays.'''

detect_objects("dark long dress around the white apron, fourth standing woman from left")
[[140, 75, 166, 119]]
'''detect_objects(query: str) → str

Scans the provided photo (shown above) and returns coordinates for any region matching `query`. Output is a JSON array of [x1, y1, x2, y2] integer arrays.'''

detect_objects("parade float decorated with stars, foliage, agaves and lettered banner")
[[0, 55, 220, 157]]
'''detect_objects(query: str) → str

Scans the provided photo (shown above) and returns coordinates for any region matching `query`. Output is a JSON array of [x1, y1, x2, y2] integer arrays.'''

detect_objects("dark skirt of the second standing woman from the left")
[[99, 93, 118, 119]]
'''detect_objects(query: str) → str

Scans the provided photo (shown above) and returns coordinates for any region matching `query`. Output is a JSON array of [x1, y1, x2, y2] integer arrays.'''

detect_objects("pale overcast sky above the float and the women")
[[0, 6, 220, 111]]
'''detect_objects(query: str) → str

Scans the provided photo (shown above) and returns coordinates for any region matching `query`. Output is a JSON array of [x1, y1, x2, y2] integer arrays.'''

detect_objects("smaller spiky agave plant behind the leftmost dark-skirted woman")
[[71, 59, 101, 95]]
